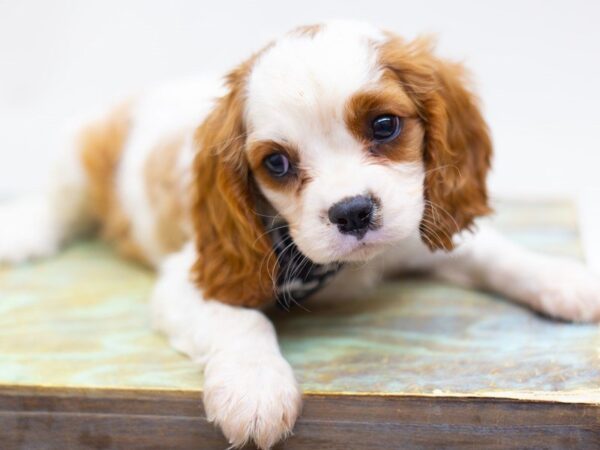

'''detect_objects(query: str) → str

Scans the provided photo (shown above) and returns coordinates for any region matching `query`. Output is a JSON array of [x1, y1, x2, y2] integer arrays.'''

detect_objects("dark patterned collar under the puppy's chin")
[[268, 222, 342, 310]]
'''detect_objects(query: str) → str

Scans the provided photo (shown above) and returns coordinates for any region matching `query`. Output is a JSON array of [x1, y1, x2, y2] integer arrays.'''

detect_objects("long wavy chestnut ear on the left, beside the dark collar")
[[192, 65, 276, 307]]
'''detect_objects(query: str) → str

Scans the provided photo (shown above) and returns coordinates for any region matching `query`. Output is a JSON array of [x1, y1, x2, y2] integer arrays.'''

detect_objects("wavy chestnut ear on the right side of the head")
[[381, 36, 492, 250]]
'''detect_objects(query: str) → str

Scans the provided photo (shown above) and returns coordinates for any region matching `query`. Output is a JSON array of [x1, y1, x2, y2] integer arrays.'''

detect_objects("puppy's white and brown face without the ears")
[[245, 25, 425, 263]]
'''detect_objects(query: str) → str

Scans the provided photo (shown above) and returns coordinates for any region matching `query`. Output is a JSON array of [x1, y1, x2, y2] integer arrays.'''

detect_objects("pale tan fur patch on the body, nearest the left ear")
[[144, 132, 189, 253]]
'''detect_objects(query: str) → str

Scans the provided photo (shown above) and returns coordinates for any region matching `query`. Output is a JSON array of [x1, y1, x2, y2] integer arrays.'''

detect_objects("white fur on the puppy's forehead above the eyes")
[[246, 22, 383, 144]]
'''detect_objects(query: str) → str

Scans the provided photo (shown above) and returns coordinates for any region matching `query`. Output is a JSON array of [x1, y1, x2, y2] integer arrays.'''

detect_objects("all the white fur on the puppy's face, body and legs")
[[0, 22, 600, 449]]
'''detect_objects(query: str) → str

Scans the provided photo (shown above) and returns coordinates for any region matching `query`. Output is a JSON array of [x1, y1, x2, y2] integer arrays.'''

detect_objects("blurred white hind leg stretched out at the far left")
[[0, 130, 91, 263]]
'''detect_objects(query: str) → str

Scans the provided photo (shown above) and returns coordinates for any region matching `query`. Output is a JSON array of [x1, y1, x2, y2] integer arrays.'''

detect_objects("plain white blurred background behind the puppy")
[[0, 0, 600, 269]]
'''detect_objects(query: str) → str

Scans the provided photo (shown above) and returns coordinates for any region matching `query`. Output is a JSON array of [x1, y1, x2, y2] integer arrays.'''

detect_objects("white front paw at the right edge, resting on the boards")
[[533, 260, 600, 322]]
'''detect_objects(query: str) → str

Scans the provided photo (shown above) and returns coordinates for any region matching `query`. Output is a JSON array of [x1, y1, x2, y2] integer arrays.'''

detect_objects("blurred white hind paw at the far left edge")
[[0, 198, 59, 264]]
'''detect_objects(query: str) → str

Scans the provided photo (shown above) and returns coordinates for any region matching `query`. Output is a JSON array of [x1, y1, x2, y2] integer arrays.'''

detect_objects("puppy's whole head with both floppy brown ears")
[[193, 22, 491, 305]]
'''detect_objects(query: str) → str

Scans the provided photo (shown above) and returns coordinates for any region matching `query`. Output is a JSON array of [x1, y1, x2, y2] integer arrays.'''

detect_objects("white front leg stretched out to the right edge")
[[432, 227, 600, 322]]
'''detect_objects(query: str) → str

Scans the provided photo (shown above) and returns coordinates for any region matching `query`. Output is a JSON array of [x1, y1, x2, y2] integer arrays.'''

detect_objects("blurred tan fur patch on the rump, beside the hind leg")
[[78, 104, 147, 263]]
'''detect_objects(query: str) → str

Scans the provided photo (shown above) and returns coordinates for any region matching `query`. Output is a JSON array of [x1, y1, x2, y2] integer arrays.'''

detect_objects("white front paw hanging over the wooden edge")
[[204, 351, 302, 449]]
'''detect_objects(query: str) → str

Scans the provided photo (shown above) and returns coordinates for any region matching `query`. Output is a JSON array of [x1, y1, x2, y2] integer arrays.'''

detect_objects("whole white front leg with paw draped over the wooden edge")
[[152, 244, 301, 449]]
